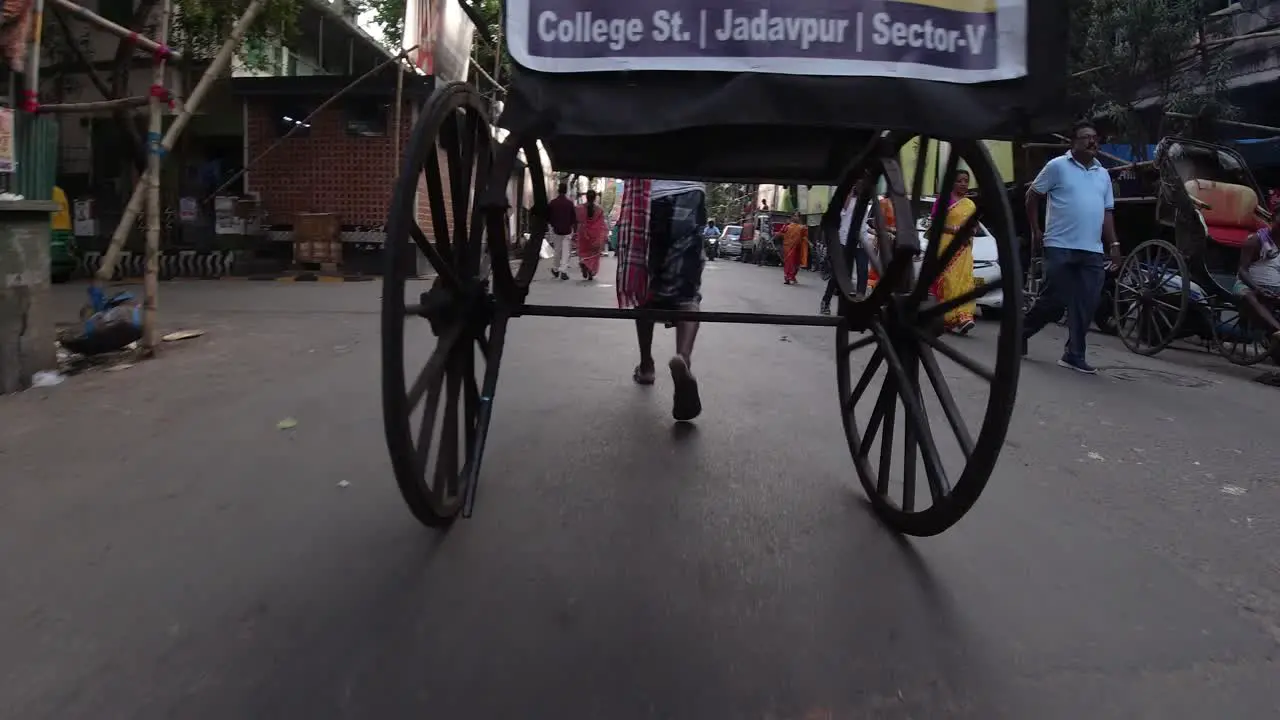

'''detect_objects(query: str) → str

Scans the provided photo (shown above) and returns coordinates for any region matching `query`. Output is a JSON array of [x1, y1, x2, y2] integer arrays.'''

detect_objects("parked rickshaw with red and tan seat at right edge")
[[1111, 137, 1271, 365]]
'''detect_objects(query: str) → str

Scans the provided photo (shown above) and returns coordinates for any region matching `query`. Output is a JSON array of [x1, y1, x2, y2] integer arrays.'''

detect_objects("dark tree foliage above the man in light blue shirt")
[[1069, 0, 1233, 145]]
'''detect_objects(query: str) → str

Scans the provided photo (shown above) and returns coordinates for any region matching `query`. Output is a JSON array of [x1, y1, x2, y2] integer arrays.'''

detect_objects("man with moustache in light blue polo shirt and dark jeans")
[[1023, 122, 1120, 375]]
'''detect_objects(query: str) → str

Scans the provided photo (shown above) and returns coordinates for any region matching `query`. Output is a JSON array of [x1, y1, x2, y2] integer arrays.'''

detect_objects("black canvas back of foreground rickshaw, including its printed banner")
[[499, 0, 1068, 183]]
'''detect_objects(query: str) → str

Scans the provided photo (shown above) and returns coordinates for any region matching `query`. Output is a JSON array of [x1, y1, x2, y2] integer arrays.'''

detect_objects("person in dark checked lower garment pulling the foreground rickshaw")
[[617, 179, 707, 421]]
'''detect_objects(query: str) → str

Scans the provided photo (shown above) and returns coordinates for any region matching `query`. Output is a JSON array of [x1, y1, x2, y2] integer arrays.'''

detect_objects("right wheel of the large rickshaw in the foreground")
[[823, 136, 1023, 536]]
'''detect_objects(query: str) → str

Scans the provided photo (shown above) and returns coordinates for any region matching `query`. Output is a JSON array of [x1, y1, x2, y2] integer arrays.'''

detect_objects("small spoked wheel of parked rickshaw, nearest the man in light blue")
[[1114, 240, 1192, 355]]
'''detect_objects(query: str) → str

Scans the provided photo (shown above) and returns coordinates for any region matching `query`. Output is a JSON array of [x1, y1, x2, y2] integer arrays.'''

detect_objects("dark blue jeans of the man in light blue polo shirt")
[[1023, 247, 1107, 363]]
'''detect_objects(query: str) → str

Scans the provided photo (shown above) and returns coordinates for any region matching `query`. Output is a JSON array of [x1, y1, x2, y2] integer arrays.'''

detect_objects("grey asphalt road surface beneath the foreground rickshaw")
[[0, 261, 1280, 720]]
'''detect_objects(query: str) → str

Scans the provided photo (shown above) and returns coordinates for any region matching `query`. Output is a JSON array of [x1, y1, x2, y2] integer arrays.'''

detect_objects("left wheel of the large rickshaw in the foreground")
[[381, 85, 509, 527]]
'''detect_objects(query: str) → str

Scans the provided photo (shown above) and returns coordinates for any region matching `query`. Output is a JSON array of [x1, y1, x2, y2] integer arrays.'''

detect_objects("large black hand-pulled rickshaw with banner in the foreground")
[[381, 0, 1066, 536]]
